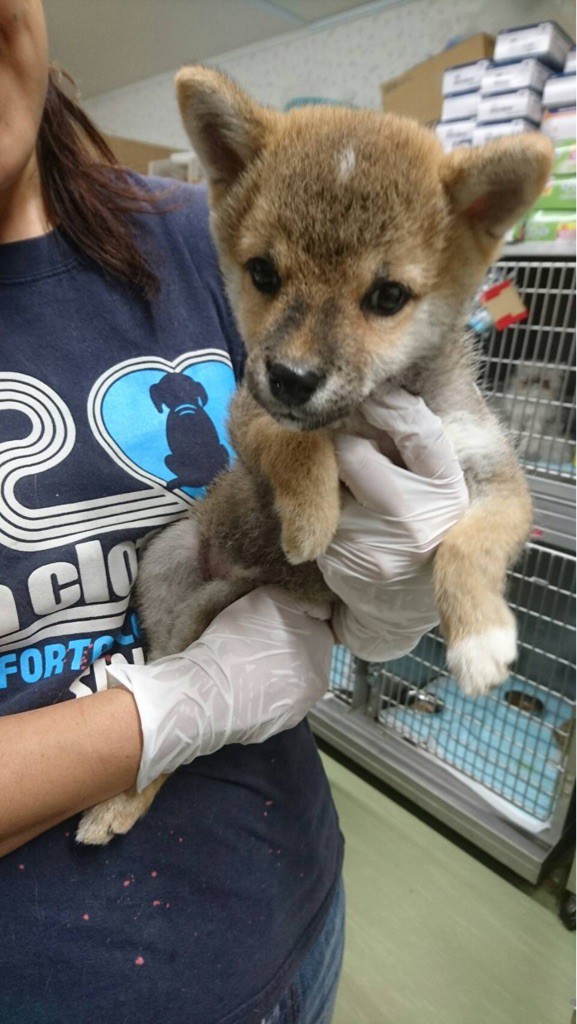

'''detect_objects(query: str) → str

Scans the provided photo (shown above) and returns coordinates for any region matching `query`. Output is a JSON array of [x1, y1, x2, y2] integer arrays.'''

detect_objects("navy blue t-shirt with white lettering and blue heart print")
[[0, 179, 342, 1024]]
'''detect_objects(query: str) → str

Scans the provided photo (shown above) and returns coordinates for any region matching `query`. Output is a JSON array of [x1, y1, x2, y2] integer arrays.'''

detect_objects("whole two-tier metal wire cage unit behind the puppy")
[[311, 251, 576, 882]]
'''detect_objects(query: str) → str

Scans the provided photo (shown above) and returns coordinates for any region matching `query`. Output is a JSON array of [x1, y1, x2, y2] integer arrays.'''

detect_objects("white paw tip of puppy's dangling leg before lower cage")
[[447, 628, 517, 696]]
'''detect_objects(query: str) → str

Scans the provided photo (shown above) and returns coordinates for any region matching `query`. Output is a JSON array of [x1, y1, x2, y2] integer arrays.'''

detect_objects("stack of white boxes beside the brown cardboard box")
[[436, 22, 575, 152]]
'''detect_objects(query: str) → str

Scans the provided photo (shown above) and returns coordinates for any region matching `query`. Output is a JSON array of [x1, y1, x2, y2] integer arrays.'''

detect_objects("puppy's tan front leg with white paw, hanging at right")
[[434, 471, 531, 696]]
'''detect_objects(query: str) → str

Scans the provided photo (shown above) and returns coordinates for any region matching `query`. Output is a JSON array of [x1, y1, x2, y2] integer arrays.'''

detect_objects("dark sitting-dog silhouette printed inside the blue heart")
[[150, 373, 230, 490]]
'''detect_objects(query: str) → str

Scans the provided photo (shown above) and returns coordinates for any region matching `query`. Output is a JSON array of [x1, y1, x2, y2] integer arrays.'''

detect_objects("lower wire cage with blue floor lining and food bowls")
[[367, 544, 575, 831]]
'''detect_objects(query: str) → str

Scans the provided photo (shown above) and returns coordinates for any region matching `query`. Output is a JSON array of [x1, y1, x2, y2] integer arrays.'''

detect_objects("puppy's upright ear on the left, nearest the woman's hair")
[[176, 66, 275, 189]]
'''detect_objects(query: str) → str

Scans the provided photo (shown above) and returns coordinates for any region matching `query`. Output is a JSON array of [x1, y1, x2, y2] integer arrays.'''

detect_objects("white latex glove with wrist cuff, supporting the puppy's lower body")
[[107, 587, 334, 791]]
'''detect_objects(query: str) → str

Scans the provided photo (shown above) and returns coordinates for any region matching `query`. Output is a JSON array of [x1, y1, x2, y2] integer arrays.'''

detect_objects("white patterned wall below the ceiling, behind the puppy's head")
[[85, 0, 575, 148]]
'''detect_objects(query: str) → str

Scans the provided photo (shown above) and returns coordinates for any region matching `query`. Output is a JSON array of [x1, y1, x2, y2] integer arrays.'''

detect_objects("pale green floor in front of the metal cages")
[[323, 755, 575, 1024]]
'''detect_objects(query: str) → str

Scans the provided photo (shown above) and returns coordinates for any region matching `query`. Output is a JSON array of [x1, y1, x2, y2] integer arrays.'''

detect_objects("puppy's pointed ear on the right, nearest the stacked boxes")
[[441, 132, 553, 244]]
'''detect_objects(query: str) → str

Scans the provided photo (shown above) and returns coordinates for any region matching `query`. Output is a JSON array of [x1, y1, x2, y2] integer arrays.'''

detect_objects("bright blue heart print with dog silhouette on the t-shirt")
[[100, 358, 236, 498]]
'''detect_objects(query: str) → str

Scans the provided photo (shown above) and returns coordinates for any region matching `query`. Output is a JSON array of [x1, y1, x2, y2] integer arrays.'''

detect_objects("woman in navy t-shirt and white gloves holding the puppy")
[[0, 0, 466, 1024]]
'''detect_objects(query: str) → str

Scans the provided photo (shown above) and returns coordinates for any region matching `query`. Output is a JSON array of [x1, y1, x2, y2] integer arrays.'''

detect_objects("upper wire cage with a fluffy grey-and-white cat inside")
[[481, 259, 575, 481]]
